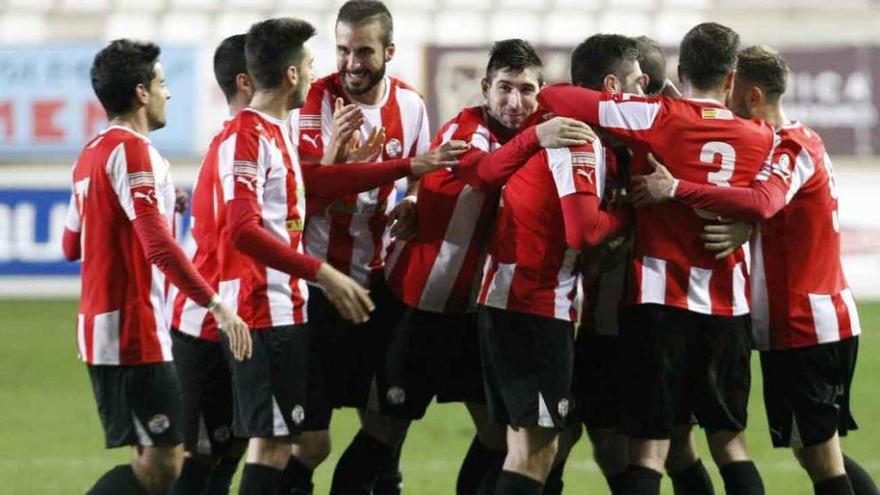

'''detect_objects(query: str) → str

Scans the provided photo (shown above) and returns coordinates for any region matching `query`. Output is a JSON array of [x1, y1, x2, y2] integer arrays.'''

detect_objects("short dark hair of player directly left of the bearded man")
[[245, 17, 315, 89]]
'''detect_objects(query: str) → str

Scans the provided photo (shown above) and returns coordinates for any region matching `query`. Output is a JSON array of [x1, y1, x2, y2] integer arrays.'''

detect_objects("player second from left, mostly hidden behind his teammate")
[[171, 34, 254, 495]]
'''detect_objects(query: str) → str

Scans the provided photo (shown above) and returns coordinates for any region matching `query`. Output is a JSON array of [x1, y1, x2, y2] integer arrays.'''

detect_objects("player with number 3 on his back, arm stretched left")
[[539, 23, 773, 494]]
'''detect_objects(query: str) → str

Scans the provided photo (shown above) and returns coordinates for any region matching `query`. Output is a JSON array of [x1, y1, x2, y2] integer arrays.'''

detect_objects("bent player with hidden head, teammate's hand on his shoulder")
[[478, 55, 625, 494]]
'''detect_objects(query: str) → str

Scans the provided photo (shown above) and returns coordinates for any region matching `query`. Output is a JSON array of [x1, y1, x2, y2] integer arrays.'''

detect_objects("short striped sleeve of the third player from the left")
[[217, 126, 268, 204]]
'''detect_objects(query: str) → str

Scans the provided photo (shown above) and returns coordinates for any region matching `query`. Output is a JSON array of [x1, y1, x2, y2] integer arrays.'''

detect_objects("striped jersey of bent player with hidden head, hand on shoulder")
[[479, 141, 605, 322]]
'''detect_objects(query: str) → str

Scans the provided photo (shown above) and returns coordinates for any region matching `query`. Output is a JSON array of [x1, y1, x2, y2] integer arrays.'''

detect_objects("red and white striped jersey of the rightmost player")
[[752, 123, 861, 349]]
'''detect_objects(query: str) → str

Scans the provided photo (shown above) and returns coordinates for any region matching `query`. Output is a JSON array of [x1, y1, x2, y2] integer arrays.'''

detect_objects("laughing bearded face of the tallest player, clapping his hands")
[[336, 21, 394, 95]]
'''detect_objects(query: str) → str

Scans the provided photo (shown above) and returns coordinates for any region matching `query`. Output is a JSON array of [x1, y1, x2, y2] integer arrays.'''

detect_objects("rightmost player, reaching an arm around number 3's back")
[[638, 46, 877, 495]]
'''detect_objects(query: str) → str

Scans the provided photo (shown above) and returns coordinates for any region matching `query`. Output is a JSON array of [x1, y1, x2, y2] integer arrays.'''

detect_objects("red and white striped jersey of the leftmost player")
[[66, 126, 174, 366]]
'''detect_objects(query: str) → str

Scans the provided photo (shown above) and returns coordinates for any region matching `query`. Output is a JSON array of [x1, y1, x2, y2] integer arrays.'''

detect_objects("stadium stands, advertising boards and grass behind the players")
[[0, 0, 880, 495]]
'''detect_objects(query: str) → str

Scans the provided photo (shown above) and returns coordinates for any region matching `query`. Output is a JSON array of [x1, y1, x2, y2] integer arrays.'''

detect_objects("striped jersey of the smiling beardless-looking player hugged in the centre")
[[385, 107, 501, 313]]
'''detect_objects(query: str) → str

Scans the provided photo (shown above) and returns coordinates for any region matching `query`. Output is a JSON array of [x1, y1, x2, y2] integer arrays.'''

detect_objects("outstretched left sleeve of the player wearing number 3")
[[538, 84, 666, 142]]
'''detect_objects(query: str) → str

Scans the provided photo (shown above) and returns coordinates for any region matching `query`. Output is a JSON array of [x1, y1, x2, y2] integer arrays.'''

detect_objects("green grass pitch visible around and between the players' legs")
[[0, 300, 880, 495]]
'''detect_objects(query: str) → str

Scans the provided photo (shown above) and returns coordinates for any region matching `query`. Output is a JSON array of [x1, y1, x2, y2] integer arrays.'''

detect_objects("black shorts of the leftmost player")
[[88, 362, 182, 449]]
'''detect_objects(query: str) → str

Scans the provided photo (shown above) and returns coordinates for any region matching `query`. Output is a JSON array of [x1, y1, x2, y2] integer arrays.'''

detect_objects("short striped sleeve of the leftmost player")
[[107, 139, 161, 220]]
